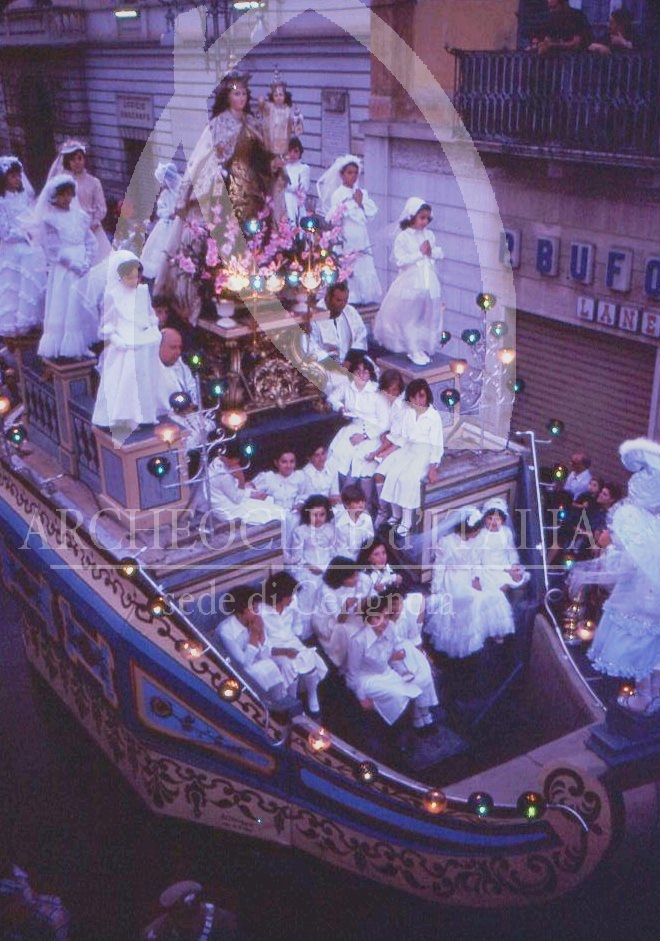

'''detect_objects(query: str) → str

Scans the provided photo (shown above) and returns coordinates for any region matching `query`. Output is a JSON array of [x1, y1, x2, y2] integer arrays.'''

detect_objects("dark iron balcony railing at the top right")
[[452, 49, 660, 168]]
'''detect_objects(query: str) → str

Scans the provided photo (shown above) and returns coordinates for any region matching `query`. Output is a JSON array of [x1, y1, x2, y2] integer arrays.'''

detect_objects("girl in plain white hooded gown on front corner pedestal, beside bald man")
[[92, 249, 161, 430]]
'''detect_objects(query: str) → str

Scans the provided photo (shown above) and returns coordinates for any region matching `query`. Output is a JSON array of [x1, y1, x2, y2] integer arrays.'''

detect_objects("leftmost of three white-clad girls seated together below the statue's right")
[[328, 355, 389, 486]]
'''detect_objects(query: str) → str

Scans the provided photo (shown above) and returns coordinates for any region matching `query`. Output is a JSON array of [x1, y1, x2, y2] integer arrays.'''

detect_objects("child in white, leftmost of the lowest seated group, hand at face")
[[214, 585, 286, 700]]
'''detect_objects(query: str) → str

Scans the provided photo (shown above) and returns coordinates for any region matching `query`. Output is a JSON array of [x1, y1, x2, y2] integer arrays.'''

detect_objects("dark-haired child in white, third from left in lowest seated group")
[[312, 556, 369, 673]]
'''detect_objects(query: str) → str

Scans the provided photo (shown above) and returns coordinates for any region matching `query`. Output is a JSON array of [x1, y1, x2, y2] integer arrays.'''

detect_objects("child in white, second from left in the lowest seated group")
[[259, 571, 328, 715]]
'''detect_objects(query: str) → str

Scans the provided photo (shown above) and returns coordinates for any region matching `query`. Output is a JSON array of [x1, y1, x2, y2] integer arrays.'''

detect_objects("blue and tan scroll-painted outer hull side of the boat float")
[[0, 467, 611, 907]]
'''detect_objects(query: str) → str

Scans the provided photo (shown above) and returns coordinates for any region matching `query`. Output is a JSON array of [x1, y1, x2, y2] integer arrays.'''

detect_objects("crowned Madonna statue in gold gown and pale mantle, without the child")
[[155, 72, 283, 324]]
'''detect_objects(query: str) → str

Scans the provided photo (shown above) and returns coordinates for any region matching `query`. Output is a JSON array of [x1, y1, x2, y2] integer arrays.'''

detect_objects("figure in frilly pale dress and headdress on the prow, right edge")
[[570, 438, 660, 715]]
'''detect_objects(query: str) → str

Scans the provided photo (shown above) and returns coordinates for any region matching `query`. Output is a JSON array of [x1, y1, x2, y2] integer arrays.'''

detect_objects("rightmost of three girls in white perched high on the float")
[[377, 379, 444, 536]]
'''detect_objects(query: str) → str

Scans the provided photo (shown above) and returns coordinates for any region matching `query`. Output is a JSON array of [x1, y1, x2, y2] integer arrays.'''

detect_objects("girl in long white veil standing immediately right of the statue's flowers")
[[316, 154, 383, 304]]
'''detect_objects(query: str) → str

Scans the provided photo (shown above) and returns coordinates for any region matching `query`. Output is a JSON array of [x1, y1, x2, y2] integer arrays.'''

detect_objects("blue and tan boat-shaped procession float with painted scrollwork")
[[0, 341, 654, 907]]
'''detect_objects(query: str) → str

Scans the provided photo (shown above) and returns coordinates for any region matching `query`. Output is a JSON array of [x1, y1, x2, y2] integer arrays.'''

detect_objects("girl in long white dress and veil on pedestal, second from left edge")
[[35, 174, 98, 358]]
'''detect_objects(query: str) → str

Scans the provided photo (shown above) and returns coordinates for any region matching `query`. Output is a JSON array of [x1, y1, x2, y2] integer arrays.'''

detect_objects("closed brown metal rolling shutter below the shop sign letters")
[[512, 312, 656, 483]]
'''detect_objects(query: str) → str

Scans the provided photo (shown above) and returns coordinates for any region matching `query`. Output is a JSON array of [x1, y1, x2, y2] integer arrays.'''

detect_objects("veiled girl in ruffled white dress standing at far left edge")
[[0, 155, 46, 337]]
